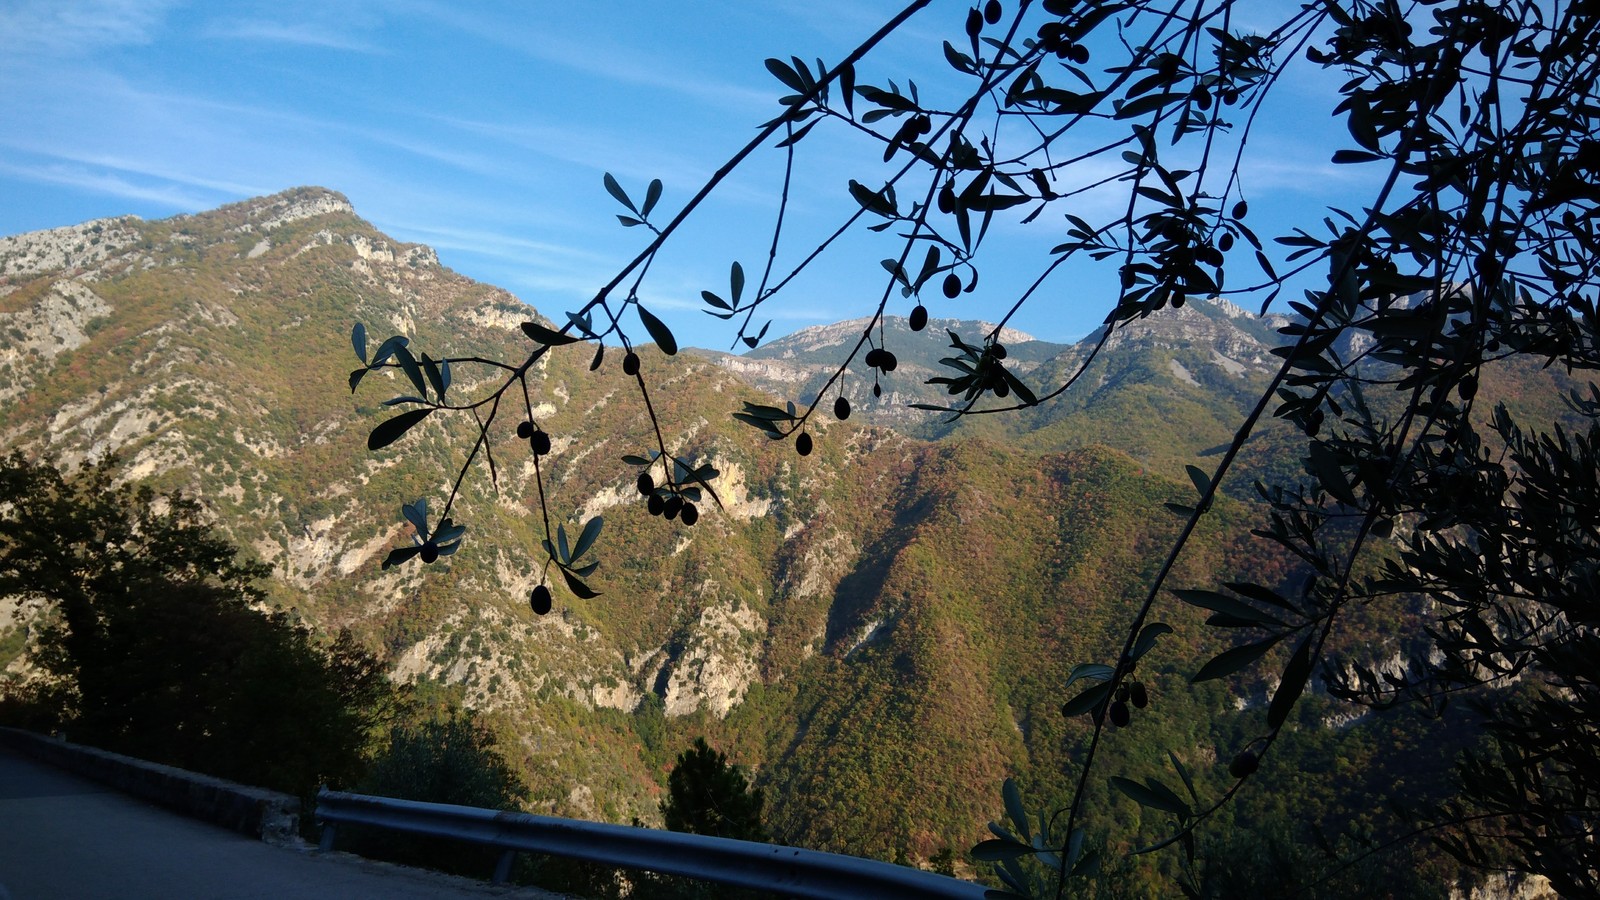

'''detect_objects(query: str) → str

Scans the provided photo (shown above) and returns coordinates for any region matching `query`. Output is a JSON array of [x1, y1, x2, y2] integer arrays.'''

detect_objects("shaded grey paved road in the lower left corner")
[[0, 748, 557, 900]]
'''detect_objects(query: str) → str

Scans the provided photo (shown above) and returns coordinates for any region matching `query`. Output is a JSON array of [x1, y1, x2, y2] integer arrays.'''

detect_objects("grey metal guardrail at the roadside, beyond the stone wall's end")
[[317, 788, 984, 900]]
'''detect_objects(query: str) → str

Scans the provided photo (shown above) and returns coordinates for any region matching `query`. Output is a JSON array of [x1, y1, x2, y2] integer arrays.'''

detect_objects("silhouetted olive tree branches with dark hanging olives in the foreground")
[[350, 0, 1600, 894]]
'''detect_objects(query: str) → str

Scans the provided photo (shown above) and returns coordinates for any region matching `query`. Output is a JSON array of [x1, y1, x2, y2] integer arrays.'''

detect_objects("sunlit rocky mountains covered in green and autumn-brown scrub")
[[0, 187, 1549, 879]]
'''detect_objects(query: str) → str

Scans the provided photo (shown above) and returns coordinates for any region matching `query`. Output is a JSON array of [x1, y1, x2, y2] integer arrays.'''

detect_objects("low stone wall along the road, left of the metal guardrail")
[[0, 729, 301, 846]]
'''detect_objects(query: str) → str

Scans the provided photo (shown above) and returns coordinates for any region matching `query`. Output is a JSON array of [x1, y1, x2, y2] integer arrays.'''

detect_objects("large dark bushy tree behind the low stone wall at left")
[[0, 452, 392, 794]]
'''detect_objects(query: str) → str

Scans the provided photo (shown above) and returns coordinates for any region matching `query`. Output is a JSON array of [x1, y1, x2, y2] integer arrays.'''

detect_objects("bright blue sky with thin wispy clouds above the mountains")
[[0, 0, 1363, 348]]
